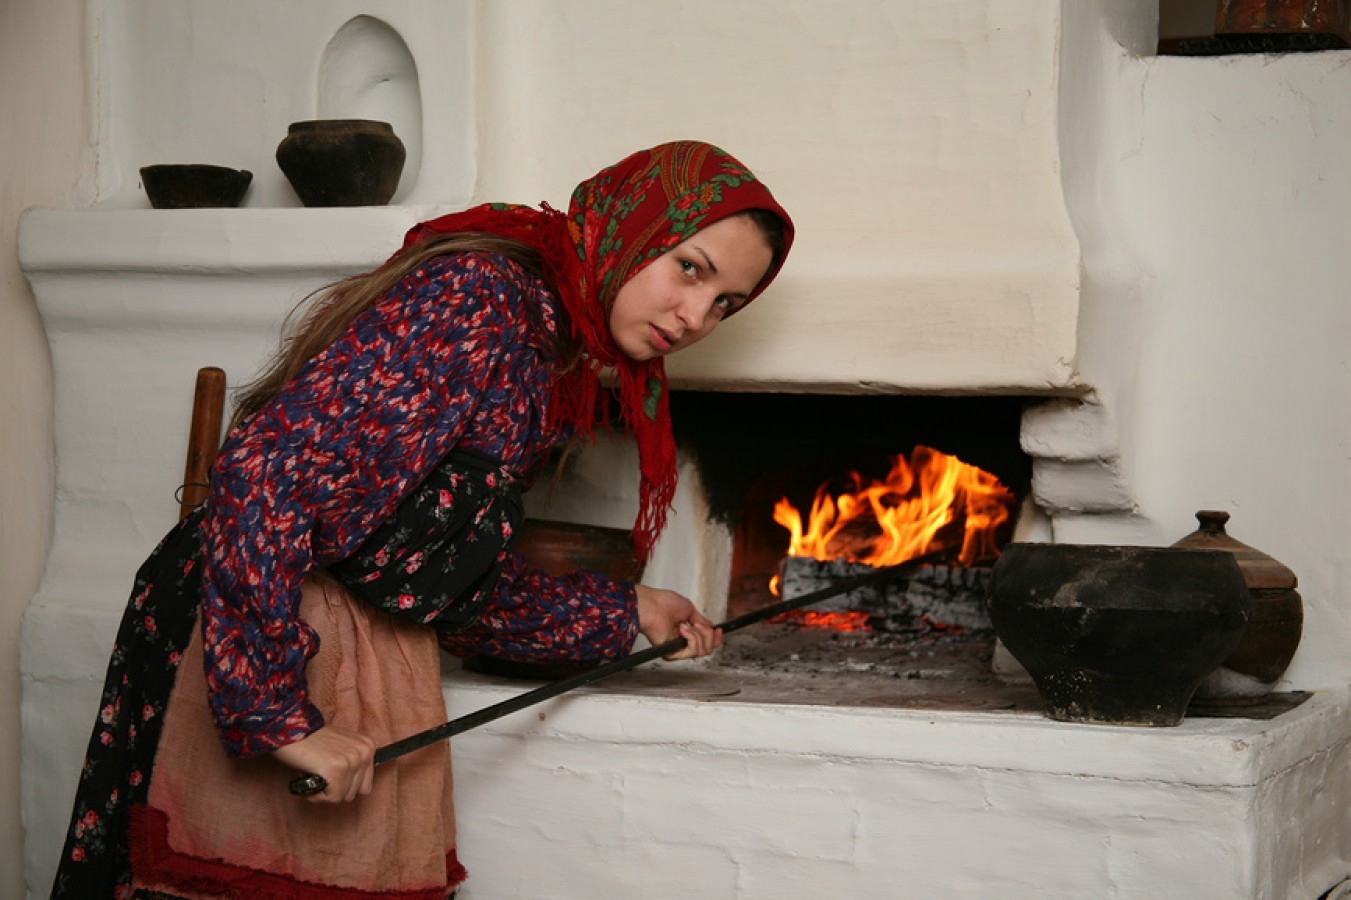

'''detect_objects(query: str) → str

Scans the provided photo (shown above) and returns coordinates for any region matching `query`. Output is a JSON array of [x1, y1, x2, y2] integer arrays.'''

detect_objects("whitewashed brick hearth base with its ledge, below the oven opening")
[[446, 666, 1351, 900]]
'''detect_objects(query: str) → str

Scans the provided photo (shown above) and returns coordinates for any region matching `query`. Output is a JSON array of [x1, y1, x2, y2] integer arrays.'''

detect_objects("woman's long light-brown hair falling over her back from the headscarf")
[[230, 231, 581, 428]]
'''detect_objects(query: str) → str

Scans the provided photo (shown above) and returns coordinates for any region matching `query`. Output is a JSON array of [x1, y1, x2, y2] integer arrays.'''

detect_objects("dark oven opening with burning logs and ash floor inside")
[[671, 392, 1032, 708]]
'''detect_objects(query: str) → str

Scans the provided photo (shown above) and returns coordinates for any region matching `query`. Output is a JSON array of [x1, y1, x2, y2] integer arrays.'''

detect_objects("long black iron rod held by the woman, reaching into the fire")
[[289, 550, 950, 796]]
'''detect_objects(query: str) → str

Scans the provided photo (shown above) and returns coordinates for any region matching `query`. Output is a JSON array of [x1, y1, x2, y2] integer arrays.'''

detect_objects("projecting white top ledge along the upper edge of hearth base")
[[444, 672, 1351, 788]]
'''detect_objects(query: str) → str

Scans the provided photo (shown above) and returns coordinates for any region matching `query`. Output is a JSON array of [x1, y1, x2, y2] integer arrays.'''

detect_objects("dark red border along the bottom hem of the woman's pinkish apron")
[[131, 803, 469, 900]]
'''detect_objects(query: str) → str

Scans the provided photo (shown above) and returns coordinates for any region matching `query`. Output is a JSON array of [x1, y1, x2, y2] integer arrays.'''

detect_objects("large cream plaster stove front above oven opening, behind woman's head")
[[478, 0, 1079, 392]]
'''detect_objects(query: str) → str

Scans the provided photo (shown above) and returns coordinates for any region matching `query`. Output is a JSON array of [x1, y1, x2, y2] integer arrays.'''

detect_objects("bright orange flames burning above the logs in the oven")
[[774, 446, 1013, 567]]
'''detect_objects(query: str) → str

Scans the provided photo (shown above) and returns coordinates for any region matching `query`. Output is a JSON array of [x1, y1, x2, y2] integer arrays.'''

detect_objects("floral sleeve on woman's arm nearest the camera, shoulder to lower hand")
[[201, 255, 528, 757]]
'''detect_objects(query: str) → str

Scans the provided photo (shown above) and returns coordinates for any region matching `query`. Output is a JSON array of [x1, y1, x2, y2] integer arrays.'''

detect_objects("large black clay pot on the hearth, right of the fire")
[[988, 543, 1251, 726]]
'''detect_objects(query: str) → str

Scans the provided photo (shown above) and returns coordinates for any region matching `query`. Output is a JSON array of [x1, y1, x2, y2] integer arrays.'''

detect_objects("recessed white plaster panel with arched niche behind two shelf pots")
[[89, 0, 476, 208]]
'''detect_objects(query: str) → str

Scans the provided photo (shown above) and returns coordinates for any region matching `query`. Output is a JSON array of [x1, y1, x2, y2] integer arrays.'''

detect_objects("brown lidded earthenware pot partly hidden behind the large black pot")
[[1173, 509, 1304, 701]]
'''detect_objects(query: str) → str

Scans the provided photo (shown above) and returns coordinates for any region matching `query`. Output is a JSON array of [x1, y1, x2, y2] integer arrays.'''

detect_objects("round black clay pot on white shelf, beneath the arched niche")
[[277, 119, 407, 207]]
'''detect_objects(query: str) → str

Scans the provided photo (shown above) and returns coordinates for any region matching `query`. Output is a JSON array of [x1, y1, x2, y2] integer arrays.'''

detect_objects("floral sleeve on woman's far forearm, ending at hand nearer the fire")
[[438, 553, 638, 662]]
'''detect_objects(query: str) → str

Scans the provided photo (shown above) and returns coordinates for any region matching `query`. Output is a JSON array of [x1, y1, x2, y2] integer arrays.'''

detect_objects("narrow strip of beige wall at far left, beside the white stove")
[[0, 0, 92, 897]]
